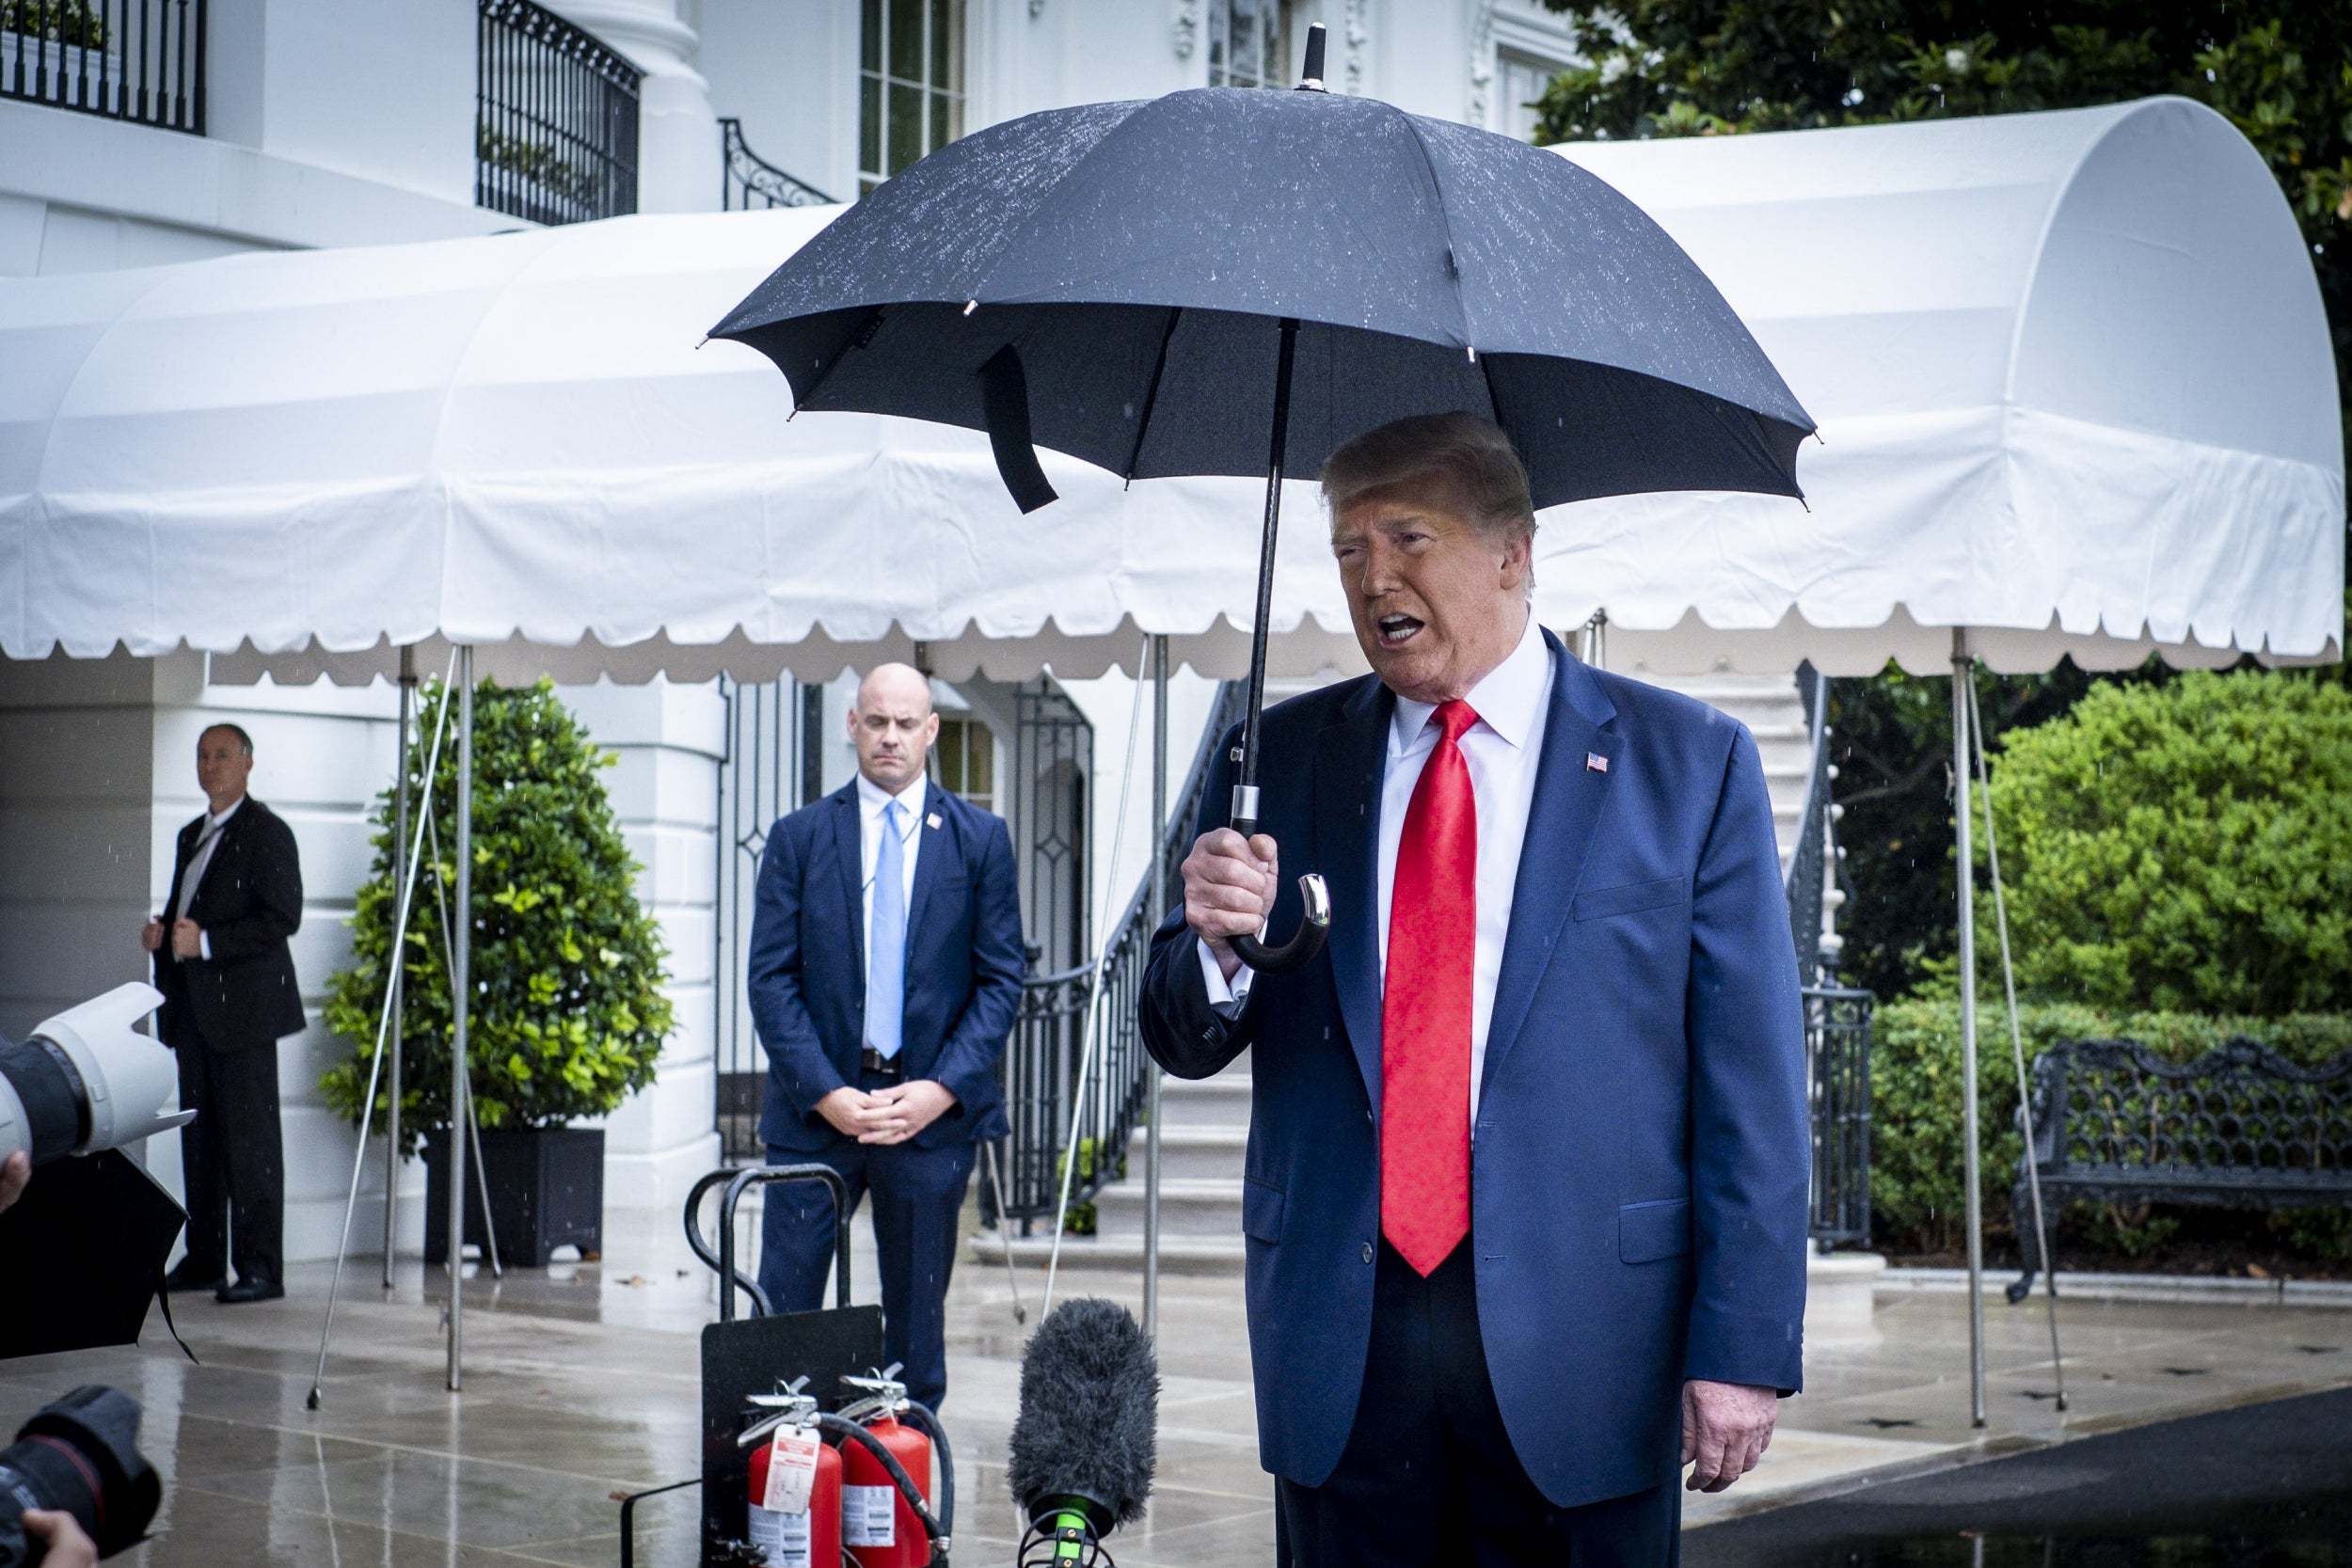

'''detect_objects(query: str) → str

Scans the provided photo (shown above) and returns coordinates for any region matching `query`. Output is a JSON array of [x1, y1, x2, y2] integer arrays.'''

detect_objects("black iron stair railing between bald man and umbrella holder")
[[981, 682, 1247, 1234]]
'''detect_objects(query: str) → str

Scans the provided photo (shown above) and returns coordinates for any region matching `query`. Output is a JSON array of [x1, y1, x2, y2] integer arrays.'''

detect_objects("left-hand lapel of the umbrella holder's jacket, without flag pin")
[[1312, 679, 1395, 1119]]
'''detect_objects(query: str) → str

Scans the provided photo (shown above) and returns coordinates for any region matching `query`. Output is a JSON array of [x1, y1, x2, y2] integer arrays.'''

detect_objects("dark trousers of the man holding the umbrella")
[[1275, 1242, 1682, 1568]]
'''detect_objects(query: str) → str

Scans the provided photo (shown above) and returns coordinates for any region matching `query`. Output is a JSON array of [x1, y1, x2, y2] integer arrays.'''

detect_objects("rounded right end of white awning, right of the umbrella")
[[1538, 99, 2345, 674]]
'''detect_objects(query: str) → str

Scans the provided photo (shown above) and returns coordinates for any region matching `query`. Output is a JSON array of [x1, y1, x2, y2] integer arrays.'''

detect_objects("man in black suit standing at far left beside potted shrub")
[[139, 724, 304, 1303]]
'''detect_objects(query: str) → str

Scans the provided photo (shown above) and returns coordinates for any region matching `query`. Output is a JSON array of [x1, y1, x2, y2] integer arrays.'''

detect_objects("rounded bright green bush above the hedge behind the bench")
[[1979, 670, 2352, 1016]]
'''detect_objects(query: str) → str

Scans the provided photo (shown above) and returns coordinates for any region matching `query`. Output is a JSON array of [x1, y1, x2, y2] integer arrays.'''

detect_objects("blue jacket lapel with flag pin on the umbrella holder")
[[1480, 632, 1623, 1093]]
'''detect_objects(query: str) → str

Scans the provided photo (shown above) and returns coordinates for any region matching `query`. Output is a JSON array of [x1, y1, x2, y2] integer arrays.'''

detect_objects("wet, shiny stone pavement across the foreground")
[[0, 1220, 2352, 1568]]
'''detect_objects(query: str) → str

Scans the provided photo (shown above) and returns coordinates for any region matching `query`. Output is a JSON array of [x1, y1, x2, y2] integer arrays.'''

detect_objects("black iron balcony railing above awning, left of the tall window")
[[473, 0, 644, 223]]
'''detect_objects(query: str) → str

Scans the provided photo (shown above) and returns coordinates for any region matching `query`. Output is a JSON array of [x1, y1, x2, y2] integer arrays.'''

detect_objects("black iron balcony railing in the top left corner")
[[0, 0, 205, 136]]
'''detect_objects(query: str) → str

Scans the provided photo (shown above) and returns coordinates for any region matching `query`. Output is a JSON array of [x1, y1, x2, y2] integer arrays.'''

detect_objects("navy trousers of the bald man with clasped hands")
[[760, 1074, 972, 1411]]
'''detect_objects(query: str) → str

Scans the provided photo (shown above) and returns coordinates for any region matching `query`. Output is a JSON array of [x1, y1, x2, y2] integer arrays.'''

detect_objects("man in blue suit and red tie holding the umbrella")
[[1141, 414, 1809, 1568]]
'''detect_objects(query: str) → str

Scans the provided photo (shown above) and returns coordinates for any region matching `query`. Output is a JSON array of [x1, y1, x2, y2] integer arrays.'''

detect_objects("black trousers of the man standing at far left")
[[174, 1039, 287, 1281]]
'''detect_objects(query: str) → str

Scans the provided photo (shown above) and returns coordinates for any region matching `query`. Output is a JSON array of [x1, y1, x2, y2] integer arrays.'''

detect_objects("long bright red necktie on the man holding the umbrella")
[[1381, 698, 1477, 1276]]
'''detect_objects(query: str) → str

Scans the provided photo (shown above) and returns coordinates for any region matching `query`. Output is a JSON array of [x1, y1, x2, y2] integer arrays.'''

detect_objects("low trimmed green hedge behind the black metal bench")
[[1870, 992, 2352, 1256]]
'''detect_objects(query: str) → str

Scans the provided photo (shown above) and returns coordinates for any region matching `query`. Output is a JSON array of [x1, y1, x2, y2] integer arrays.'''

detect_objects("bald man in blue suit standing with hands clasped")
[[748, 665, 1024, 1411]]
